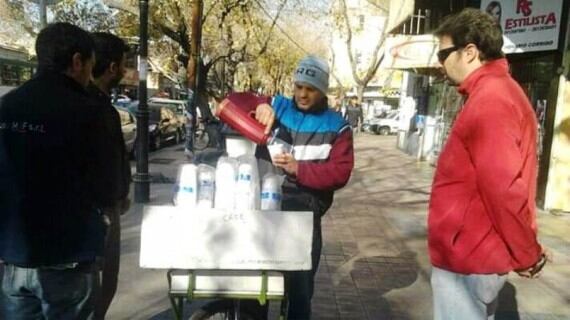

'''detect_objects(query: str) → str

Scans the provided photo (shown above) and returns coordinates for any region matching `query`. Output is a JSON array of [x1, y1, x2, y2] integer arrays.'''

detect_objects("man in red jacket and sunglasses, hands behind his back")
[[428, 9, 546, 319]]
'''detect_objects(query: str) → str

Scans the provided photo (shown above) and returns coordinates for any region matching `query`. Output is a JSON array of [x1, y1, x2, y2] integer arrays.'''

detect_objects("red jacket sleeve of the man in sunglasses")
[[467, 99, 541, 270]]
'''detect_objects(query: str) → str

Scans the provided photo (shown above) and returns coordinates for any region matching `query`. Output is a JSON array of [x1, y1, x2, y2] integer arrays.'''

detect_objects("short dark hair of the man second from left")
[[91, 32, 129, 78]]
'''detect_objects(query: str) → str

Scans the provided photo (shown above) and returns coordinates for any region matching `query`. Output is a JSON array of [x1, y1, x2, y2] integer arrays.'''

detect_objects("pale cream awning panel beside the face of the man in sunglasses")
[[380, 34, 440, 69]]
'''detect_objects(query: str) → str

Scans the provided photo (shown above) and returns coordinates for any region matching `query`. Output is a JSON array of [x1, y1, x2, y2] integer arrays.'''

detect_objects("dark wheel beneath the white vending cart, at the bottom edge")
[[188, 300, 267, 320]]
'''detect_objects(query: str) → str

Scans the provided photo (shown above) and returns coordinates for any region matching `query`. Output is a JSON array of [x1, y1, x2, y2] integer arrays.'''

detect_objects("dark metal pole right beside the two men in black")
[[133, 0, 150, 203]]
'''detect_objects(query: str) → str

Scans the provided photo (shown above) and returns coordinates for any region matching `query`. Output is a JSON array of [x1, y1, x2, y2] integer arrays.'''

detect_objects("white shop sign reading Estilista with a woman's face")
[[481, 0, 563, 53]]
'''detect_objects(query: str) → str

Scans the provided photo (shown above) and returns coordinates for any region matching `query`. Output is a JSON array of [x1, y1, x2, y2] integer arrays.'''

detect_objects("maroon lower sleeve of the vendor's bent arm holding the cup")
[[297, 129, 354, 190]]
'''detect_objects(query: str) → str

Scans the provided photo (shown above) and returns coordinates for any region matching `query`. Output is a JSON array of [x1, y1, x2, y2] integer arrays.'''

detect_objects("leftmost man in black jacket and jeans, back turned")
[[0, 23, 105, 320]]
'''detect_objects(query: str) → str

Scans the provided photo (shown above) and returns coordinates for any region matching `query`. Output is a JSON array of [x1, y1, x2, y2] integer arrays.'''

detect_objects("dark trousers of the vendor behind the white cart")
[[285, 214, 323, 320]]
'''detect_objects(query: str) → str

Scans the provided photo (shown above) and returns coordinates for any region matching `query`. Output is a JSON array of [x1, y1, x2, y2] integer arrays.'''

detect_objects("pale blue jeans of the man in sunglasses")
[[431, 267, 507, 320]]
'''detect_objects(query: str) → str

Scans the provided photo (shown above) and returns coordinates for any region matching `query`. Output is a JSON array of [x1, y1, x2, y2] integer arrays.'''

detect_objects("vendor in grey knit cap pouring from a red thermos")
[[256, 56, 354, 320]]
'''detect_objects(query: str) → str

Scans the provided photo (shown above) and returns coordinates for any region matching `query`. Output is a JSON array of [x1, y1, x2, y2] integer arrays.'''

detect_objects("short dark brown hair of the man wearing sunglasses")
[[434, 8, 504, 61]]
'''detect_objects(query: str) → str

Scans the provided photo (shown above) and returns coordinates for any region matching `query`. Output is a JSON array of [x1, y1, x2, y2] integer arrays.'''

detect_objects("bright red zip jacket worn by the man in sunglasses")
[[428, 59, 541, 274]]
